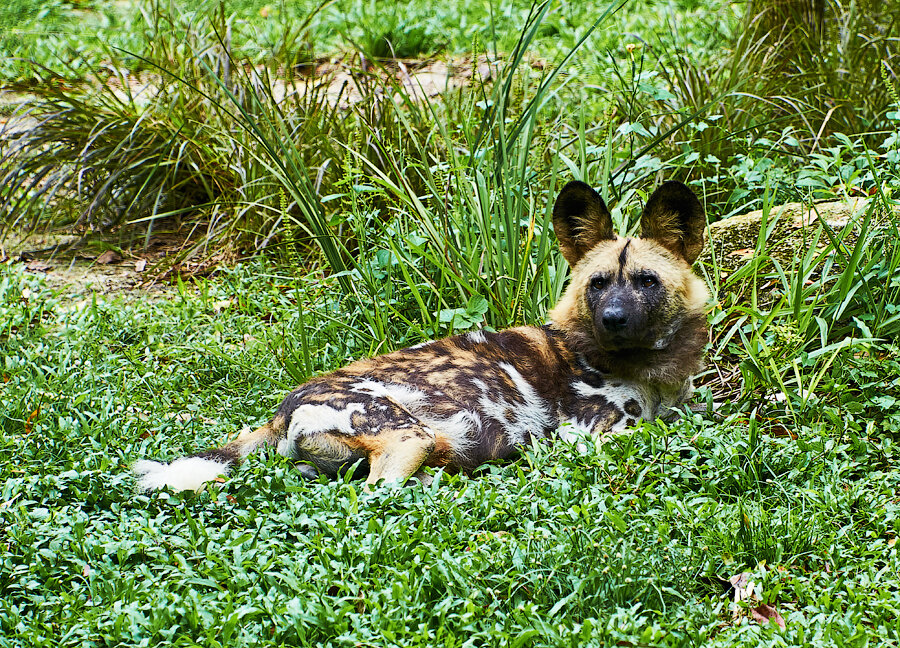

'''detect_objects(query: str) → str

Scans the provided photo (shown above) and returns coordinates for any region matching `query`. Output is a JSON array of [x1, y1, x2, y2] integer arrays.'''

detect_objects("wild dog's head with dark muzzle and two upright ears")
[[552, 181, 708, 354]]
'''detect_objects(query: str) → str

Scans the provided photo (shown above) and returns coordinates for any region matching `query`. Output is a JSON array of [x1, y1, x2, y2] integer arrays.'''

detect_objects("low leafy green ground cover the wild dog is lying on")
[[0, 262, 900, 646]]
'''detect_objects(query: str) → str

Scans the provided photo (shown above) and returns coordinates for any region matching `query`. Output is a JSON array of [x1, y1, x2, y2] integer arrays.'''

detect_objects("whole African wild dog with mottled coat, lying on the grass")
[[135, 182, 708, 490]]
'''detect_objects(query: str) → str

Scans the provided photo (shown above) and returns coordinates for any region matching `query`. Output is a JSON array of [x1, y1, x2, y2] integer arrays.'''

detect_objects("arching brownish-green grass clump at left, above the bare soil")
[[0, 2, 344, 251]]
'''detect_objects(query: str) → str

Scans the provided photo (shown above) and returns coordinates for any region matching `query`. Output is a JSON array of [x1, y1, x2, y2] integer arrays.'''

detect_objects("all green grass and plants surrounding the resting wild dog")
[[0, 2, 900, 646]]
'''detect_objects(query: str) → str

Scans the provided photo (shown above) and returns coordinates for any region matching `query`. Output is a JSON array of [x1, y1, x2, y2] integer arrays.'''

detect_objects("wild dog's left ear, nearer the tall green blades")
[[553, 180, 616, 267]]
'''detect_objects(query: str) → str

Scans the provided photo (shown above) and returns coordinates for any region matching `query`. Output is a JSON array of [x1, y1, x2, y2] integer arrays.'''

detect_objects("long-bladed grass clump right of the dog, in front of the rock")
[[712, 158, 900, 432]]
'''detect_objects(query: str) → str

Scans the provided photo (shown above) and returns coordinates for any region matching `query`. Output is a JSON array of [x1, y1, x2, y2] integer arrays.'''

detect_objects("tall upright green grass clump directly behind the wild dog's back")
[[250, 3, 652, 344]]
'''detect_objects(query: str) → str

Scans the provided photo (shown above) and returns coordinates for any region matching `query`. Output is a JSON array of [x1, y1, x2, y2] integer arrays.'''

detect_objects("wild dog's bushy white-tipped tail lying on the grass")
[[132, 415, 287, 491]]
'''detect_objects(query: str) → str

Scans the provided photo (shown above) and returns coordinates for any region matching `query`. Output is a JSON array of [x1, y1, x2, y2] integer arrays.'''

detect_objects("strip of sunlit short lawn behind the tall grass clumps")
[[0, 0, 734, 80]]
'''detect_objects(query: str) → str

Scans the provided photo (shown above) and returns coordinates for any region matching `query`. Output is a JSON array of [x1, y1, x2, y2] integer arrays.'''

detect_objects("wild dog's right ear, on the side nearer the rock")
[[641, 180, 706, 264]]
